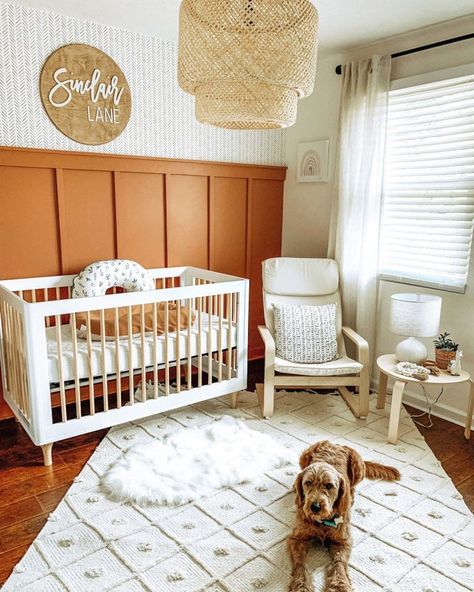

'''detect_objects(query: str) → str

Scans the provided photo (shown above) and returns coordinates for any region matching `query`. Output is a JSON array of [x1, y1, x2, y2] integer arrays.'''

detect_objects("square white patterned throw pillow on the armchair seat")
[[273, 303, 338, 364]]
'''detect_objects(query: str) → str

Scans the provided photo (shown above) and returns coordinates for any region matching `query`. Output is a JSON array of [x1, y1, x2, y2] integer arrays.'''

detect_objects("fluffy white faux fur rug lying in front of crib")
[[102, 416, 294, 505]]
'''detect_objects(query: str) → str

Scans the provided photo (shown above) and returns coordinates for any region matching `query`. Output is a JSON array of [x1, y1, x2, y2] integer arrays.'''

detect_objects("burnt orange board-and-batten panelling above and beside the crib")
[[0, 147, 286, 358]]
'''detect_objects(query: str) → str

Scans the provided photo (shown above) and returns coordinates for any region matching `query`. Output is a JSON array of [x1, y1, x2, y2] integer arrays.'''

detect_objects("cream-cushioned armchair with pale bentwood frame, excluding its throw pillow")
[[256, 257, 369, 418]]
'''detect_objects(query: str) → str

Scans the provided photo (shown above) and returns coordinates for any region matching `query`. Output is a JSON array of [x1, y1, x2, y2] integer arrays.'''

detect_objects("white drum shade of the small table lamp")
[[390, 294, 442, 337]]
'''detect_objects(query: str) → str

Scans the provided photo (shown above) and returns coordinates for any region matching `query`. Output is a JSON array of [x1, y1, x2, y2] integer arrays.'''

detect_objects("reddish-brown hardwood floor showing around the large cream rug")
[[0, 361, 474, 585]]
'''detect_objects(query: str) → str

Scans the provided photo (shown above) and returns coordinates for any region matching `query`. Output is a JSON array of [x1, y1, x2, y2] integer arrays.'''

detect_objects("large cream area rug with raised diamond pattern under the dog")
[[3, 392, 474, 592]]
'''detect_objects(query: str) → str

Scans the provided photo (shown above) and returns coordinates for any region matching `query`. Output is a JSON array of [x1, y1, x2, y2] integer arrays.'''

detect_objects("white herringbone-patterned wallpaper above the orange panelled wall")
[[0, 3, 284, 164]]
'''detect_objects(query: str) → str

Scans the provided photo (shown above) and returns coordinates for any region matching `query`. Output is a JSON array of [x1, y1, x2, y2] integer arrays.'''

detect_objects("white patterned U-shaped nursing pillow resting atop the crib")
[[72, 259, 155, 298]]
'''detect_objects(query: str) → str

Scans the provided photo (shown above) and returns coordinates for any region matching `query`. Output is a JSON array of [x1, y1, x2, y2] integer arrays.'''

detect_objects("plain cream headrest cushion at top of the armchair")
[[262, 257, 339, 296]]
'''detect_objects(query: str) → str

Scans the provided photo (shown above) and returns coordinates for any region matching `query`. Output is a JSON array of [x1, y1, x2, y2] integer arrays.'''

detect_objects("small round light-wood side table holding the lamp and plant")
[[377, 354, 474, 444]]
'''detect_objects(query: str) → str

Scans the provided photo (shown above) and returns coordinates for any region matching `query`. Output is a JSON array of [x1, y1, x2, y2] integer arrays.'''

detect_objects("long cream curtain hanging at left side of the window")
[[328, 56, 391, 352]]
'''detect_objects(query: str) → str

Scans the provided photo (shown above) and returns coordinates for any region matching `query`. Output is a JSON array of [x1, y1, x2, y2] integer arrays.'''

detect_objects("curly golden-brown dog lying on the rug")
[[288, 440, 400, 592]]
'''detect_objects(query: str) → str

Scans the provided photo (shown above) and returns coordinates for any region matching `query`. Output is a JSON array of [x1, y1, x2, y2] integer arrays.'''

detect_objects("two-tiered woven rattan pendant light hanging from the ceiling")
[[178, 0, 318, 129]]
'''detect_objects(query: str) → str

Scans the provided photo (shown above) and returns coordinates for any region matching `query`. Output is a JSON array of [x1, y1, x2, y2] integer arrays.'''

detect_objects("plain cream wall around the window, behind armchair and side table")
[[283, 16, 474, 423]]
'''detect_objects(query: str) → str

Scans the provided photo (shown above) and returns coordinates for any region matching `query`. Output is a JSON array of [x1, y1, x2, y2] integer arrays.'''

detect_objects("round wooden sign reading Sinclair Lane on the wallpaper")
[[40, 44, 132, 145]]
